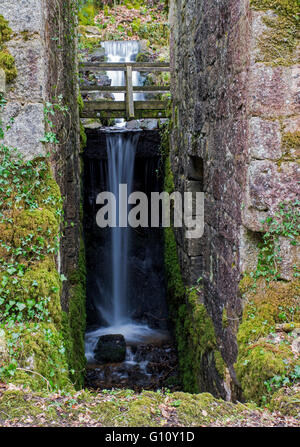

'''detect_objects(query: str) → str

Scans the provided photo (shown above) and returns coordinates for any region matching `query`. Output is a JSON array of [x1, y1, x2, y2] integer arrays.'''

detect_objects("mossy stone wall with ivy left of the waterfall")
[[0, 0, 85, 388]]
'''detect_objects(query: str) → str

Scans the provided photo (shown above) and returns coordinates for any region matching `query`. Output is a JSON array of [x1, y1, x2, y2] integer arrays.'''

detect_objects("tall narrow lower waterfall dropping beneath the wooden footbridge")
[[107, 132, 139, 326]]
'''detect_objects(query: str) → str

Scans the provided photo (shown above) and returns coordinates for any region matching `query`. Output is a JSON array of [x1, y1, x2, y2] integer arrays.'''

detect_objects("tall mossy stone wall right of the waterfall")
[[170, 0, 300, 401]]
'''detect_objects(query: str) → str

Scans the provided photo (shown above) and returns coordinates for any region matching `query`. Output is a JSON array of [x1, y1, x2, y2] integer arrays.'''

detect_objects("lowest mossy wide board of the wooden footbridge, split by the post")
[[84, 101, 168, 112]]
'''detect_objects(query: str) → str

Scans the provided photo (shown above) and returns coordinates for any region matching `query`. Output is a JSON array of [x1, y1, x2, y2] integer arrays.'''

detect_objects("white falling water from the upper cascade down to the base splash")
[[86, 41, 166, 360]]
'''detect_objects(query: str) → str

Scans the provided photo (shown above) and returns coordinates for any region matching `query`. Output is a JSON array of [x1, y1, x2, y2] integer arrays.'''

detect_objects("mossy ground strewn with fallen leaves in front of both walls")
[[0, 386, 290, 427]]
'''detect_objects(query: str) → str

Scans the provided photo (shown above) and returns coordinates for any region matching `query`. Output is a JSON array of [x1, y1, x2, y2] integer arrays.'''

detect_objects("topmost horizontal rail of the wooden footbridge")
[[79, 62, 170, 72]]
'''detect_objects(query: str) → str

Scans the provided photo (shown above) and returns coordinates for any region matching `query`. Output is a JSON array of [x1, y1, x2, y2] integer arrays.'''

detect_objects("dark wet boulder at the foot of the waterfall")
[[94, 334, 126, 363]]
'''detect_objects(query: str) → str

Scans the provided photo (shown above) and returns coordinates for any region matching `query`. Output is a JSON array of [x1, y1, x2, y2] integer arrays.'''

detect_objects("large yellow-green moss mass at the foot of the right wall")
[[235, 276, 300, 404]]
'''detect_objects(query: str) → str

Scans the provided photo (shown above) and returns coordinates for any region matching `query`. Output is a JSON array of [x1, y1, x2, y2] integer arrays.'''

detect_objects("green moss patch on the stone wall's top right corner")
[[251, 0, 299, 66]]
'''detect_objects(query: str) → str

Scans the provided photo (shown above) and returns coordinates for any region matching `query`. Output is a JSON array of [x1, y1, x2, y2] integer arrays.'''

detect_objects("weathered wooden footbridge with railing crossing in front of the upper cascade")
[[80, 62, 170, 119]]
